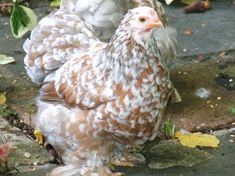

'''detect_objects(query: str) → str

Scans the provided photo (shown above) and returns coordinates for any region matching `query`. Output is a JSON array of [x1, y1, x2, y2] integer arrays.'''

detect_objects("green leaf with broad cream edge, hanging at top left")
[[10, 4, 37, 38]]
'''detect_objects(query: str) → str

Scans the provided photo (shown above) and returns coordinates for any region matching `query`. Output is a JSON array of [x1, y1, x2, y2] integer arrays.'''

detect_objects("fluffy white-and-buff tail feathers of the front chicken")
[[23, 10, 100, 85]]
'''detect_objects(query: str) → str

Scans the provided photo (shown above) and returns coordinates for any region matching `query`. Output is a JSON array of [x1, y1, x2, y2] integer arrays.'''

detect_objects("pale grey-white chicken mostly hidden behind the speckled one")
[[60, 0, 166, 41]]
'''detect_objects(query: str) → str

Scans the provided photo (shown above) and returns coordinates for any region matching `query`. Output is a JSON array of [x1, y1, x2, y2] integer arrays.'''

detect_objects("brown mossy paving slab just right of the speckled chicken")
[[168, 52, 235, 131]]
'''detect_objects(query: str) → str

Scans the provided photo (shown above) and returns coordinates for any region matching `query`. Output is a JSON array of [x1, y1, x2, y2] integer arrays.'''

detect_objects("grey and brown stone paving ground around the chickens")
[[0, 0, 235, 176]]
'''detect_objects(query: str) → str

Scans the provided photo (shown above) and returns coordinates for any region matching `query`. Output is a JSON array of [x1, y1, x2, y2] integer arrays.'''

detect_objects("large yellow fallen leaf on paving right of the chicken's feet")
[[175, 132, 220, 148]]
